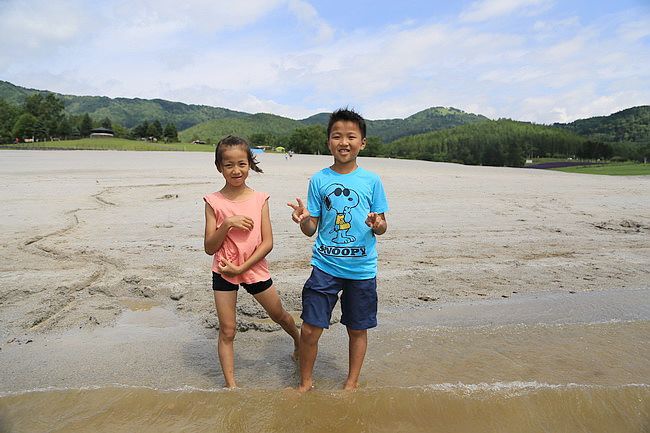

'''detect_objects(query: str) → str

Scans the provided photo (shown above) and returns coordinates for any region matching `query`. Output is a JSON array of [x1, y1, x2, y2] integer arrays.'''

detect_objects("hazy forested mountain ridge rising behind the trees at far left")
[[0, 81, 248, 130]]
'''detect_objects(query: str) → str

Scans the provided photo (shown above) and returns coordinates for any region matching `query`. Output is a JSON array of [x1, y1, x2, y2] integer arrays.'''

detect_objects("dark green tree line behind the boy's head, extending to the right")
[[237, 119, 650, 167]]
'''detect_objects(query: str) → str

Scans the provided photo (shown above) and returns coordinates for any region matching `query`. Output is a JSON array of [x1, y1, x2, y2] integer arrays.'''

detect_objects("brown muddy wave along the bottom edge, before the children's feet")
[[0, 383, 650, 433]]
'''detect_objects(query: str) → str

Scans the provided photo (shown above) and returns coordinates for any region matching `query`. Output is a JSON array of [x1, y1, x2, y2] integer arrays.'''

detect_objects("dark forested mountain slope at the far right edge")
[[553, 105, 650, 143]]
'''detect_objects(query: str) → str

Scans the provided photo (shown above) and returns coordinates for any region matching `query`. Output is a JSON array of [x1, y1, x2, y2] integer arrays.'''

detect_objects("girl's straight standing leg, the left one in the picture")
[[214, 290, 237, 388]]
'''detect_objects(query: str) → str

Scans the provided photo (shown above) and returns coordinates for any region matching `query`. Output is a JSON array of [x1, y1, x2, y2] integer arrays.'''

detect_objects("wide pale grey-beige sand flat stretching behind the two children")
[[0, 151, 650, 391]]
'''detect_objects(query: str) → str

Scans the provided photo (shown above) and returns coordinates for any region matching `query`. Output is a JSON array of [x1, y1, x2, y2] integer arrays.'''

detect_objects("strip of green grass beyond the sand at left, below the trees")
[[0, 138, 214, 152]]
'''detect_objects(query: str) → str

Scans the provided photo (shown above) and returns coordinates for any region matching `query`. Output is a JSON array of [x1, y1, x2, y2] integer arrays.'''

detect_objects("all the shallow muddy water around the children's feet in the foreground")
[[0, 290, 650, 433]]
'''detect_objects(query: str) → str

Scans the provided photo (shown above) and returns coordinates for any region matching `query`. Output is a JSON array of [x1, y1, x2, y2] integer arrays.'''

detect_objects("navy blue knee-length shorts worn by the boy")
[[300, 266, 377, 330]]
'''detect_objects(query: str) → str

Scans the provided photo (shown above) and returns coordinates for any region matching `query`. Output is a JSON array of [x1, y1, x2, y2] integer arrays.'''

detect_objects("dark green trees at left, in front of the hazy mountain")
[[0, 93, 178, 143]]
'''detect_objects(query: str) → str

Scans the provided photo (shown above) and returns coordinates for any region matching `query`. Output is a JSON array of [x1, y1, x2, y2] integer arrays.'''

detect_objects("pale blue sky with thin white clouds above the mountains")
[[0, 0, 650, 124]]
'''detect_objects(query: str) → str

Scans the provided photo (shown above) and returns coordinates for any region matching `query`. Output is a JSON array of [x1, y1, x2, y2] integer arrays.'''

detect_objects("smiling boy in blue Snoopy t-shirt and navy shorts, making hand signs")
[[288, 109, 388, 392]]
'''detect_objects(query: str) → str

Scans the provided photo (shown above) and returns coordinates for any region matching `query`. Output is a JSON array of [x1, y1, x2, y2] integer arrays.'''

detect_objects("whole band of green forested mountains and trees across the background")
[[0, 81, 650, 166]]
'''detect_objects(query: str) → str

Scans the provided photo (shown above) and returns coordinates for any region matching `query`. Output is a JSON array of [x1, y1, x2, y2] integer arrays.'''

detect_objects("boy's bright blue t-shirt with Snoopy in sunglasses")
[[307, 167, 388, 280]]
